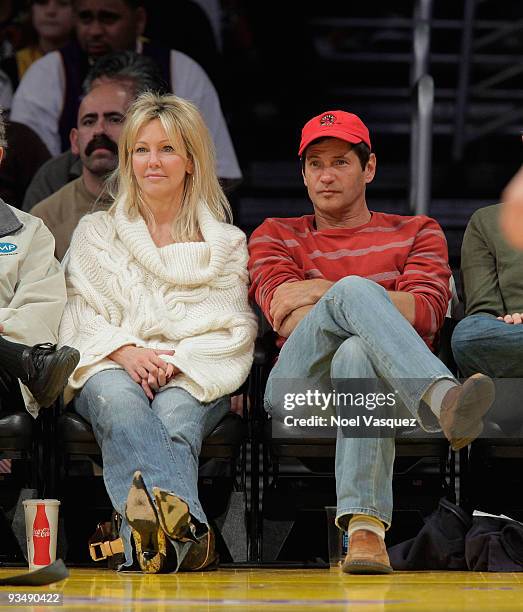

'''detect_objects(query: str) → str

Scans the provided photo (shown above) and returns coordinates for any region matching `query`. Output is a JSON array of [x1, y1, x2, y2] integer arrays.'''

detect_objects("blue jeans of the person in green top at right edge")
[[452, 314, 523, 378]]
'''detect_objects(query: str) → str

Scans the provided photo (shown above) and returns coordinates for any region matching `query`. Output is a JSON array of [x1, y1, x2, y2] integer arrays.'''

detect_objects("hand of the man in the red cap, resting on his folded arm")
[[269, 278, 334, 337]]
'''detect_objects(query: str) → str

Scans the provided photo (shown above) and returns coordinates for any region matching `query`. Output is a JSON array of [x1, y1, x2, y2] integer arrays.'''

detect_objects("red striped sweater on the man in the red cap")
[[249, 212, 451, 349]]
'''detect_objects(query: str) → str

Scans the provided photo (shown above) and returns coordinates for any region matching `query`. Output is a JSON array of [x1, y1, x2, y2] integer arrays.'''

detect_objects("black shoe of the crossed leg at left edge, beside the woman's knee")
[[22, 344, 80, 408]]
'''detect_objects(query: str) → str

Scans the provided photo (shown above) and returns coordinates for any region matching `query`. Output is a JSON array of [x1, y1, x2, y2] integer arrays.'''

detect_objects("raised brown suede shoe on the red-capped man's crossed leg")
[[439, 374, 495, 450]]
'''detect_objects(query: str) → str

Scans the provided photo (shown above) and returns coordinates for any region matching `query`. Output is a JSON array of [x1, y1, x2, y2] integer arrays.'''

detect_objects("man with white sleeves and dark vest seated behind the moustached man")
[[12, 0, 241, 180]]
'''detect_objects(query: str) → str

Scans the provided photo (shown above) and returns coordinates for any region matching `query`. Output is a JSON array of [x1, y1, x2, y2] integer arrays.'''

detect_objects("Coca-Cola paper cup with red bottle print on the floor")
[[23, 499, 60, 570]]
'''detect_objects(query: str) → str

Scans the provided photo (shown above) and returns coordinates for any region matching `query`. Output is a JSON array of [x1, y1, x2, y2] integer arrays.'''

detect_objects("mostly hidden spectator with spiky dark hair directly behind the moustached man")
[[23, 51, 167, 212]]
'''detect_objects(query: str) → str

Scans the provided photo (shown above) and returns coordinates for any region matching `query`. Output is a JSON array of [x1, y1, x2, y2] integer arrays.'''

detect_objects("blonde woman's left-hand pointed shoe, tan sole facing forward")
[[125, 472, 176, 574]]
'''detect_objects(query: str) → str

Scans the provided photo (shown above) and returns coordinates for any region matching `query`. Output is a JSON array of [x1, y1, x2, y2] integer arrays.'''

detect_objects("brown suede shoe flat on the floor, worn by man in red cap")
[[341, 529, 392, 574]]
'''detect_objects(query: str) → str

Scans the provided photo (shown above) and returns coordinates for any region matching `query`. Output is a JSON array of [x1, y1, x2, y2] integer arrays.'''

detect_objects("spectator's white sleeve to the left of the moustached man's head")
[[11, 51, 65, 156]]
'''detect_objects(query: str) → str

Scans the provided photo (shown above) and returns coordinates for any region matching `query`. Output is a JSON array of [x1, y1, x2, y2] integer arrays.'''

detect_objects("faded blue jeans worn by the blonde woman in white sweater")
[[74, 369, 230, 566]]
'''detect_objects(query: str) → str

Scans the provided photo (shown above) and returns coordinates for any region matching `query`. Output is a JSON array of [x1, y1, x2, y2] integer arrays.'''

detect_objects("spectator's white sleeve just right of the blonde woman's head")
[[171, 51, 242, 179]]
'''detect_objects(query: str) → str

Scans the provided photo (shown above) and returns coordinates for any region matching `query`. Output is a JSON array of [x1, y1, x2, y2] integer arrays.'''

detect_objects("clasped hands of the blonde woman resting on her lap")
[[108, 345, 180, 400]]
